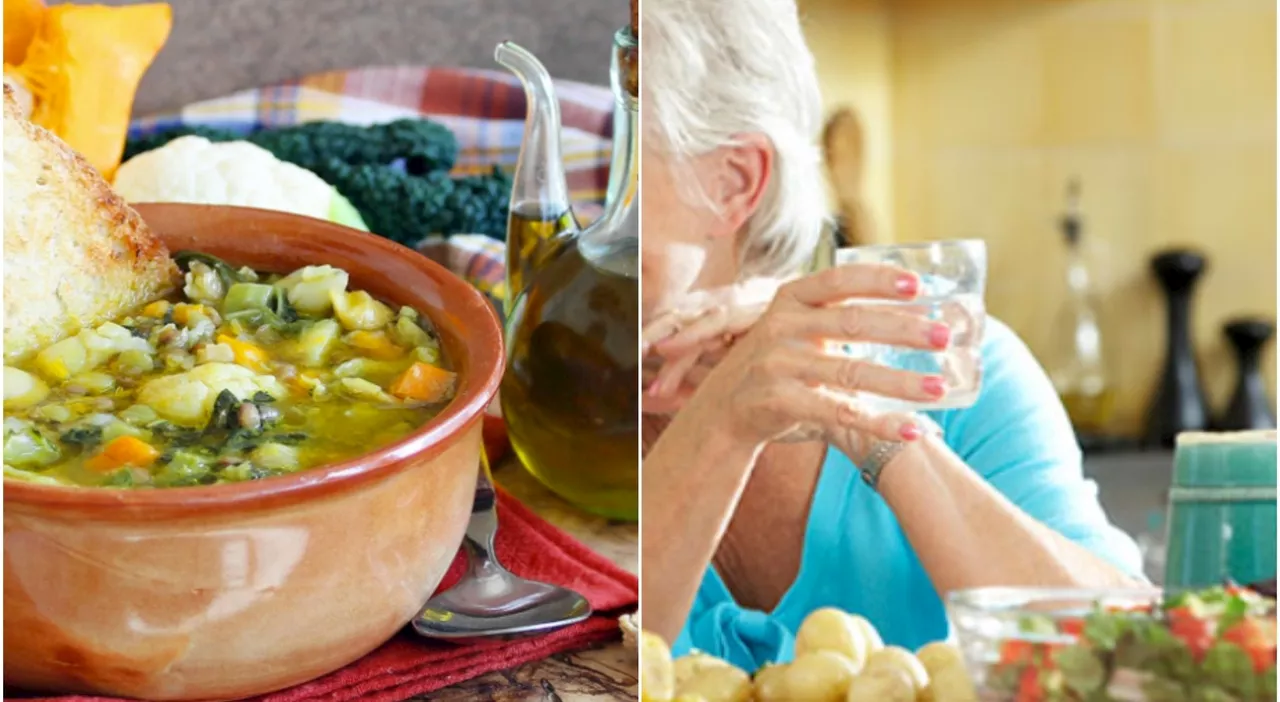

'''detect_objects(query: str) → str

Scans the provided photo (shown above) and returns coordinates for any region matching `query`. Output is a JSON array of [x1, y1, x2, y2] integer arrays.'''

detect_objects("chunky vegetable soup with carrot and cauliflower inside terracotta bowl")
[[4, 252, 456, 488]]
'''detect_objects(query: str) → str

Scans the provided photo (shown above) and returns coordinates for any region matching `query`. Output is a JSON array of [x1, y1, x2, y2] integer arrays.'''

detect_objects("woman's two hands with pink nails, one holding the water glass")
[[645, 265, 950, 460]]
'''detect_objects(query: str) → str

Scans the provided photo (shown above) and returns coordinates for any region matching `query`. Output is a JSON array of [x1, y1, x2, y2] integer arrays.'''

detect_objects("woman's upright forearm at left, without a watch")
[[640, 412, 760, 642]]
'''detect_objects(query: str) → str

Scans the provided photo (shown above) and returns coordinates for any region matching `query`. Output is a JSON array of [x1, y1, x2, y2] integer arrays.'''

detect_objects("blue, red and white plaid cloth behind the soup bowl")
[[129, 67, 613, 304]]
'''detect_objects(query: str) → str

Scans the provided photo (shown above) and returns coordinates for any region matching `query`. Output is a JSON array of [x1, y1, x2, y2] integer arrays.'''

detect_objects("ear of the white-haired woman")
[[707, 133, 773, 233]]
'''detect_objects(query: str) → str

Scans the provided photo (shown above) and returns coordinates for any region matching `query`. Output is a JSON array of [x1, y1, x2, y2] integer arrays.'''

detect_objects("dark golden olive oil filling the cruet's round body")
[[500, 238, 640, 520]]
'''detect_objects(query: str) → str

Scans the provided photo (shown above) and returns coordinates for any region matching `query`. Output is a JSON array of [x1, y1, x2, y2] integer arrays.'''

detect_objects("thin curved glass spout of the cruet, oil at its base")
[[494, 41, 577, 313]]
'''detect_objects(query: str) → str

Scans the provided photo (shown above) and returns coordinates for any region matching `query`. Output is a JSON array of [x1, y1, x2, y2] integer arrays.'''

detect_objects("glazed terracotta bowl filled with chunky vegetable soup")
[[4, 204, 503, 699]]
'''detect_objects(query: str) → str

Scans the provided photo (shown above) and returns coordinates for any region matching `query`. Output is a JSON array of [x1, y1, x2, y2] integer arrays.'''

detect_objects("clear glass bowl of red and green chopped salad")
[[947, 587, 1276, 702]]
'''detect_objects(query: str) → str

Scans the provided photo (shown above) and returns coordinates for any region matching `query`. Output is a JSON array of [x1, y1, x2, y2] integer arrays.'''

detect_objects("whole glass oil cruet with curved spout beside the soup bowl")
[[495, 27, 640, 520]]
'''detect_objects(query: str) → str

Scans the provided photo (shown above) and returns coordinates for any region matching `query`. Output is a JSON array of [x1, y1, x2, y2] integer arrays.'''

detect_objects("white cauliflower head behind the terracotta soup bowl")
[[114, 136, 337, 219]]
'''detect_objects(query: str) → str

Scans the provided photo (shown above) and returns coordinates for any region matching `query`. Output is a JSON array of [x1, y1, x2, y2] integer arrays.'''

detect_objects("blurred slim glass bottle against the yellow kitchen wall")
[[1048, 179, 1115, 436]]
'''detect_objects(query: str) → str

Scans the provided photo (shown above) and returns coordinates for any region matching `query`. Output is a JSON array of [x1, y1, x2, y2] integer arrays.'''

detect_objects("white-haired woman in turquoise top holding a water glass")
[[641, 0, 1142, 670]]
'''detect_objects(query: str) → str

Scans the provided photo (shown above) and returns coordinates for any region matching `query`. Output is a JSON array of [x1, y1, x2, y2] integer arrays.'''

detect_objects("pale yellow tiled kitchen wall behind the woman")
[[801, 0, 1276, 429]]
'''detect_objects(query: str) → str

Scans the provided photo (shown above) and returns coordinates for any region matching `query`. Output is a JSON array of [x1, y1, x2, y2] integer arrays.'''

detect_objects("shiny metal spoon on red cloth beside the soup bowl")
[[413, 456, 591, 643]]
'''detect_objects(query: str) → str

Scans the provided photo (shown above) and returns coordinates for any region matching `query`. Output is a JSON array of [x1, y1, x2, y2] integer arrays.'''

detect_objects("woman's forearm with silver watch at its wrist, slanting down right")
[[878, 439, 1135, 594]]
